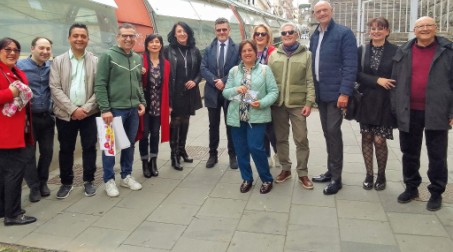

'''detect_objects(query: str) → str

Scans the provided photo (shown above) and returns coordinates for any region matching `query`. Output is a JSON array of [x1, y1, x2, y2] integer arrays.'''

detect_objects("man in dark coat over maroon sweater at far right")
[[391, 16, 453, 211]]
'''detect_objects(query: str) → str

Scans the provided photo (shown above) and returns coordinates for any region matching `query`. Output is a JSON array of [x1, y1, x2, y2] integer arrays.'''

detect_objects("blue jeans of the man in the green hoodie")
[[102, 108, 139, 182]]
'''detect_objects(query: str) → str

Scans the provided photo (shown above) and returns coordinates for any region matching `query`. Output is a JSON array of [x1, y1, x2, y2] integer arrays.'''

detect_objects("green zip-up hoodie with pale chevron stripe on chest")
[[94, 46, 146, 113]]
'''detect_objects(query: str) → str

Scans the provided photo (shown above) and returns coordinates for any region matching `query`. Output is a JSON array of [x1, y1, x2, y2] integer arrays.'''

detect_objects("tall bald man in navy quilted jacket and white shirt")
[[310, 1, 357, 195]]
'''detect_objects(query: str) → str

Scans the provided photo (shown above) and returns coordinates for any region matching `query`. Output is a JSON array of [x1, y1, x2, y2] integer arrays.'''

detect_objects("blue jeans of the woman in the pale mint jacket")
[[231, 122, 273, 182]]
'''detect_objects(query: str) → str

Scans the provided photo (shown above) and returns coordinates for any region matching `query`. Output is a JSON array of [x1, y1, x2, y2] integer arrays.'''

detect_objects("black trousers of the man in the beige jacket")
[[56, 115, 97, 185]]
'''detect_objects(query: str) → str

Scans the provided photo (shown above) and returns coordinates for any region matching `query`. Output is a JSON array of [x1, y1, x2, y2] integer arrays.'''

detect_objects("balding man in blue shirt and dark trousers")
[[17, 37, 55, 202]]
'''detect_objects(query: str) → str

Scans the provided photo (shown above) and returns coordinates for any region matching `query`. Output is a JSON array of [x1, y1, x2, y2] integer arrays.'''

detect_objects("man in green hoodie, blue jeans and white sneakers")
[[95, 23, 146, 197]]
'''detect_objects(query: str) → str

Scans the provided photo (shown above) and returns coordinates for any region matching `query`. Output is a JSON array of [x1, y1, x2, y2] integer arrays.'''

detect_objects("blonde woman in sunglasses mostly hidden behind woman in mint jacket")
[[253, 24, 280, 167]]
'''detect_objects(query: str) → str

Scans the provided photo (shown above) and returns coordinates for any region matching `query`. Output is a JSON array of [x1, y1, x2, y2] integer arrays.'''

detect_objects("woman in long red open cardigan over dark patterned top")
[[139, 34, 170, 178]]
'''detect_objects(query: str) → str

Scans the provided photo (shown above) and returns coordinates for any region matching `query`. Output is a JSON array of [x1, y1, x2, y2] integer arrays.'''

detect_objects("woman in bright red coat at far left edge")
[[0, 38, 36, 226]]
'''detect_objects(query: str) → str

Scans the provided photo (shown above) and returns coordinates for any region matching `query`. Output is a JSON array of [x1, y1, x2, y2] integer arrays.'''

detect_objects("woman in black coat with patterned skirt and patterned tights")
[[357, 17, 398, 190]]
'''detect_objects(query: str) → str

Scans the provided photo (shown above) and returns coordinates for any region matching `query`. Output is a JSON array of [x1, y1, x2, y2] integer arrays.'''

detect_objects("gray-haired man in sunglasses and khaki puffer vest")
[[268, 23, 315, 189]]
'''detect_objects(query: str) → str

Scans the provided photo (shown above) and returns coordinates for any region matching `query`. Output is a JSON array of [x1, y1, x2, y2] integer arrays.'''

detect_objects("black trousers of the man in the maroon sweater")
[[399, 110, 448, 195]]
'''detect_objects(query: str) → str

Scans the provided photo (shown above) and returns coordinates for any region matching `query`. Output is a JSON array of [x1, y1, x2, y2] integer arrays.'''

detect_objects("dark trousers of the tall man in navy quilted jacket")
[[318, 101, 343, 181]]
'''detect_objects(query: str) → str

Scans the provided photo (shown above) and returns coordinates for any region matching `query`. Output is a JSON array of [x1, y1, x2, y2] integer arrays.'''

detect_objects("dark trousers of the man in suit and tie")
[[208, 94, 236, 156]]
